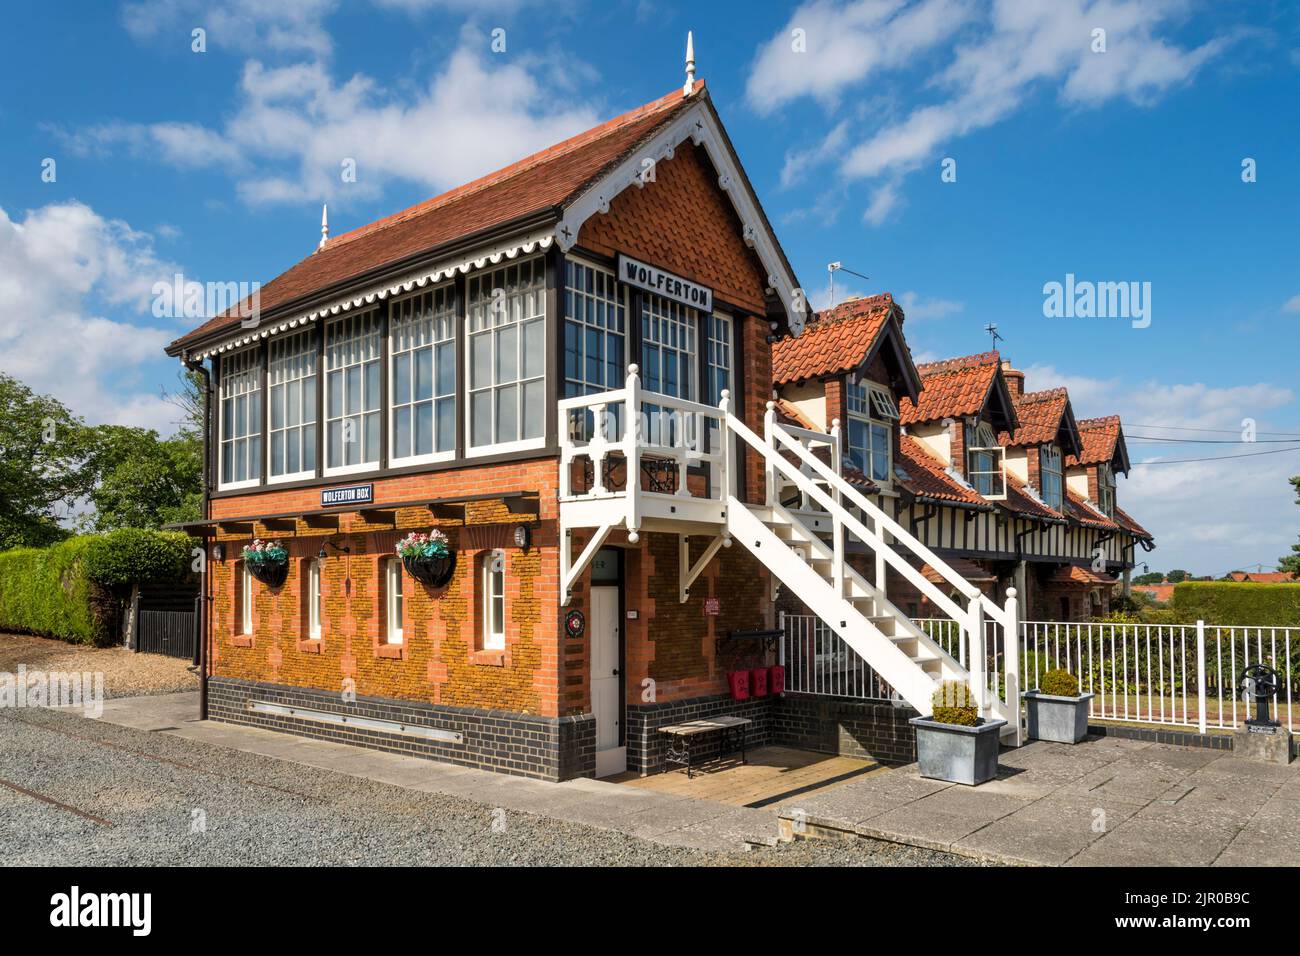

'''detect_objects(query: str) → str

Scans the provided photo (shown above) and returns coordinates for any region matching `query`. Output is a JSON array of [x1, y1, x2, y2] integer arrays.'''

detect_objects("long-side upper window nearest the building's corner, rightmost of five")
[[467, 258, 546, 454]]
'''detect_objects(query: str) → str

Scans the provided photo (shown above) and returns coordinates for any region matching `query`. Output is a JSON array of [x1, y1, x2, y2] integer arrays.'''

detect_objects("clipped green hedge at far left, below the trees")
[[0, 528, 191, 644]]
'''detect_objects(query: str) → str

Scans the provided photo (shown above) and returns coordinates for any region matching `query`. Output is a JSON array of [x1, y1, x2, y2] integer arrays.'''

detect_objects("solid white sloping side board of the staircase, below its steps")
[[727, 496, 935, 714]]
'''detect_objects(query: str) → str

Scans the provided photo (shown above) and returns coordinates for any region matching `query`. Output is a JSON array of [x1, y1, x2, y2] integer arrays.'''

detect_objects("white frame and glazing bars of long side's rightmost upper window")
[[462, 256, 554, 458]]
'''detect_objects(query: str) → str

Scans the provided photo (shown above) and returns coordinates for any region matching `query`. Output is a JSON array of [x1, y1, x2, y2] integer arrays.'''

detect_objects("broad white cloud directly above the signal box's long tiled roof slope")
[[79, 31, 598, 204]]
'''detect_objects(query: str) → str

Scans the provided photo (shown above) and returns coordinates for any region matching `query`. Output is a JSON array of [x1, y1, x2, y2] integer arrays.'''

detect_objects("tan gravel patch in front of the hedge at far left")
[[0, 633, 199, 697]]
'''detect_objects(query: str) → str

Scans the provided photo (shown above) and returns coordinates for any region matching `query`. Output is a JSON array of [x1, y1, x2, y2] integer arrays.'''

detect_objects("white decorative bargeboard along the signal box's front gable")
[[555, 100, 809, 336]]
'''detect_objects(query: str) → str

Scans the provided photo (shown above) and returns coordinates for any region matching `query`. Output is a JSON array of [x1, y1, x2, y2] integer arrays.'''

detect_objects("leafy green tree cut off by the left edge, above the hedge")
[[0, 372, 92, 550]]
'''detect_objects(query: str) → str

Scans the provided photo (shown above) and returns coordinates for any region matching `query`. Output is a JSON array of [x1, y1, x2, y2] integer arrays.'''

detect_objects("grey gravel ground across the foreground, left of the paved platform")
[[0, 710, 974, 866]]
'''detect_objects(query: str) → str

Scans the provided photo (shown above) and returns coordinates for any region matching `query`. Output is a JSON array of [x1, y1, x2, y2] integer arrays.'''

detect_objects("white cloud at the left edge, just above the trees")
[[0, 202, 179, 432]]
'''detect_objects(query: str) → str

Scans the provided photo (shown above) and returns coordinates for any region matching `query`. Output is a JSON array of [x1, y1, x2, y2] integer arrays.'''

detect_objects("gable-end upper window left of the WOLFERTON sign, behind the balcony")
[[564, 259, 627, 441]]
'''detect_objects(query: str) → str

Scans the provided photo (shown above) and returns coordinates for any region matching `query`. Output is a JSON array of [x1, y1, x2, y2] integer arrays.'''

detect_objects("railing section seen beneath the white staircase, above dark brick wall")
[[776, 611, 900, 701]]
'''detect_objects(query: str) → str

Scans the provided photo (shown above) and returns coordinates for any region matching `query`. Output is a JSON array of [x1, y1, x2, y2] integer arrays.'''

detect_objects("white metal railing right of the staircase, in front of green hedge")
[[1021, 620, 1300, 732]]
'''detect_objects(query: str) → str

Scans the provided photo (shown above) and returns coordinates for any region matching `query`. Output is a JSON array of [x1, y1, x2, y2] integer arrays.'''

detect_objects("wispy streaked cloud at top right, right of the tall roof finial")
[[749, 0, 1231, 225]]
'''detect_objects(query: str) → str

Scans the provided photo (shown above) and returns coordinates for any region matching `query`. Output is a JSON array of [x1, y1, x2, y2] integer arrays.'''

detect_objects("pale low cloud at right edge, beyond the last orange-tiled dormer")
[[1024, 365, 1300, 574]]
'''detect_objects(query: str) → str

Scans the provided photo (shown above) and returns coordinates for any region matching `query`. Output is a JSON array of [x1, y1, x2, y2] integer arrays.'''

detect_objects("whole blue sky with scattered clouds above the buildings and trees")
[[0, 0, 1300, 575]]
